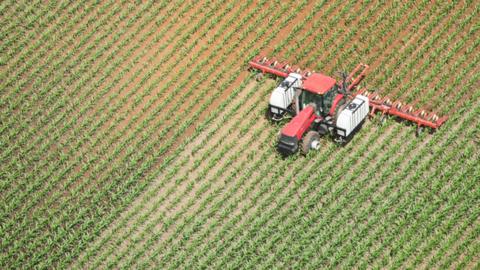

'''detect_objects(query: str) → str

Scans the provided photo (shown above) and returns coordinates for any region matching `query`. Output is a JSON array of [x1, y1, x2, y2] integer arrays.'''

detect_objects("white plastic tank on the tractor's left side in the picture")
[[270, 73, 302, 114]]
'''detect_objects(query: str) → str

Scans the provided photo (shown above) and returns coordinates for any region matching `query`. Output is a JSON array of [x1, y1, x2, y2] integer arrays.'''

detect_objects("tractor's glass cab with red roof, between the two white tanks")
[[298, 73, 338, 117]]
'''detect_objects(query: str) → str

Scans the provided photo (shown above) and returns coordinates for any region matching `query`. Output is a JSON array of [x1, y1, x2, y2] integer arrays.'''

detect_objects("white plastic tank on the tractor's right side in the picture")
[[336, 95, 369, 137]]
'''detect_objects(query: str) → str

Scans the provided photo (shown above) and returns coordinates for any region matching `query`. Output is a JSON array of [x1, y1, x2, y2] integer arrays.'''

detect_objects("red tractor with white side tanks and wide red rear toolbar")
[[249, 56, 447, 156]]
